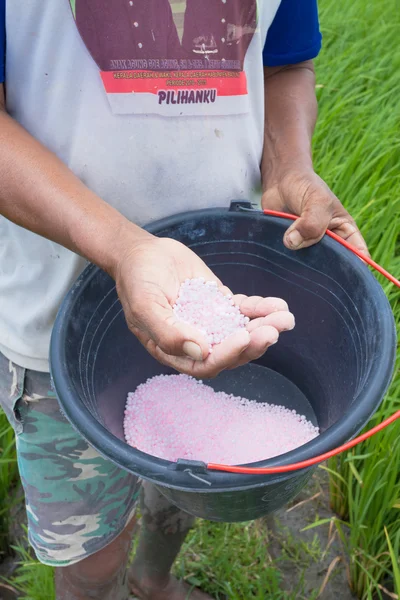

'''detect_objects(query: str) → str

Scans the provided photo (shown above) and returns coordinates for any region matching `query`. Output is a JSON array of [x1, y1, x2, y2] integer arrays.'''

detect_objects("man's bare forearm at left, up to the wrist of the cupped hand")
[[0, 85, 149, 274]]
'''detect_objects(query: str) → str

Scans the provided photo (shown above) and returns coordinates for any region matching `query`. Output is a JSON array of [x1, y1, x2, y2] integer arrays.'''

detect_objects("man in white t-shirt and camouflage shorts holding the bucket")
[[0, 0, 366, 600]]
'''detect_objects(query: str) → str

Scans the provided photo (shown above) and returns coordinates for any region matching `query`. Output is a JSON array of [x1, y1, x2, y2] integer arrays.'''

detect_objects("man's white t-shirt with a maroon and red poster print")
[[0, 0, 320, 371]]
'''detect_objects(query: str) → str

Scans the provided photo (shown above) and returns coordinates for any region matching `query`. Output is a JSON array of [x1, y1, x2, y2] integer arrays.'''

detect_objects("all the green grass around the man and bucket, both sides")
[[0, 0, 400, 600]]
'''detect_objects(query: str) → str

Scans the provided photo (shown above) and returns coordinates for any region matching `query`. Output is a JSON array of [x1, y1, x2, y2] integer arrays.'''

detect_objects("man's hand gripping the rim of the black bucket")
[[262, 167, 368, 255]]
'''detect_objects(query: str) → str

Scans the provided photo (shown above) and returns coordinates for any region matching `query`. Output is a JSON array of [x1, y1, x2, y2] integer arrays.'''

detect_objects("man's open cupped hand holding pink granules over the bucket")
[[112, 236, 294, 378]]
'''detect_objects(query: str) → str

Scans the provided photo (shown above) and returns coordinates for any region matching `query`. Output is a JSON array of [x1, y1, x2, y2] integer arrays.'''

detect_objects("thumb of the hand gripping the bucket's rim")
[[283, 202, 332, 250]]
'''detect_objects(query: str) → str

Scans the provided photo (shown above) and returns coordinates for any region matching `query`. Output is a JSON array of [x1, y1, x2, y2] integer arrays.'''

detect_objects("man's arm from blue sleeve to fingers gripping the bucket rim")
[[261, 60, 368, 254]]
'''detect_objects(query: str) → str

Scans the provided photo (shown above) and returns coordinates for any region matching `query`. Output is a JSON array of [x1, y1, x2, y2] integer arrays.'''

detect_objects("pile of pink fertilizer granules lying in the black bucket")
[[124, 375, 319, 465]]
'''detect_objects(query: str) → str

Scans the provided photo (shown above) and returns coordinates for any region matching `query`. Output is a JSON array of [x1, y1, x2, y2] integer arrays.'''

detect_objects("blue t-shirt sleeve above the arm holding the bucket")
[[263, 0, 322, 67]]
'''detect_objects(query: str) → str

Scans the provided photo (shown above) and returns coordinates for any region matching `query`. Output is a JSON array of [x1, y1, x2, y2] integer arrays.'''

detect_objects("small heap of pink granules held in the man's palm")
[[173, 277, 250, 349]]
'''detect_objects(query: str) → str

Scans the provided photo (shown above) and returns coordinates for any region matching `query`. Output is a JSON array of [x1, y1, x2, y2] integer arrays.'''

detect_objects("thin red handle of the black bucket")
[[207, 207, 400, 475]]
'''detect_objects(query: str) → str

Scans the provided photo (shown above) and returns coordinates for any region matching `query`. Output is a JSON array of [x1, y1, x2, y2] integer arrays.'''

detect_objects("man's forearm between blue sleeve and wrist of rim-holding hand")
[[261, 61, 317, 189]]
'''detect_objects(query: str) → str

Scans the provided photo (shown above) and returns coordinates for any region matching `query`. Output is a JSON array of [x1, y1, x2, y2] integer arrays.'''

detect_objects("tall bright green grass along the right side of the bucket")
[[314, 0, 400, 600]]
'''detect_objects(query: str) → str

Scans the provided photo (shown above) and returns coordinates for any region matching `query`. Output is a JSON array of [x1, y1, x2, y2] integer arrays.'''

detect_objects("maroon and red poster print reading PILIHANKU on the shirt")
[[70, 0, 257, 116]]
